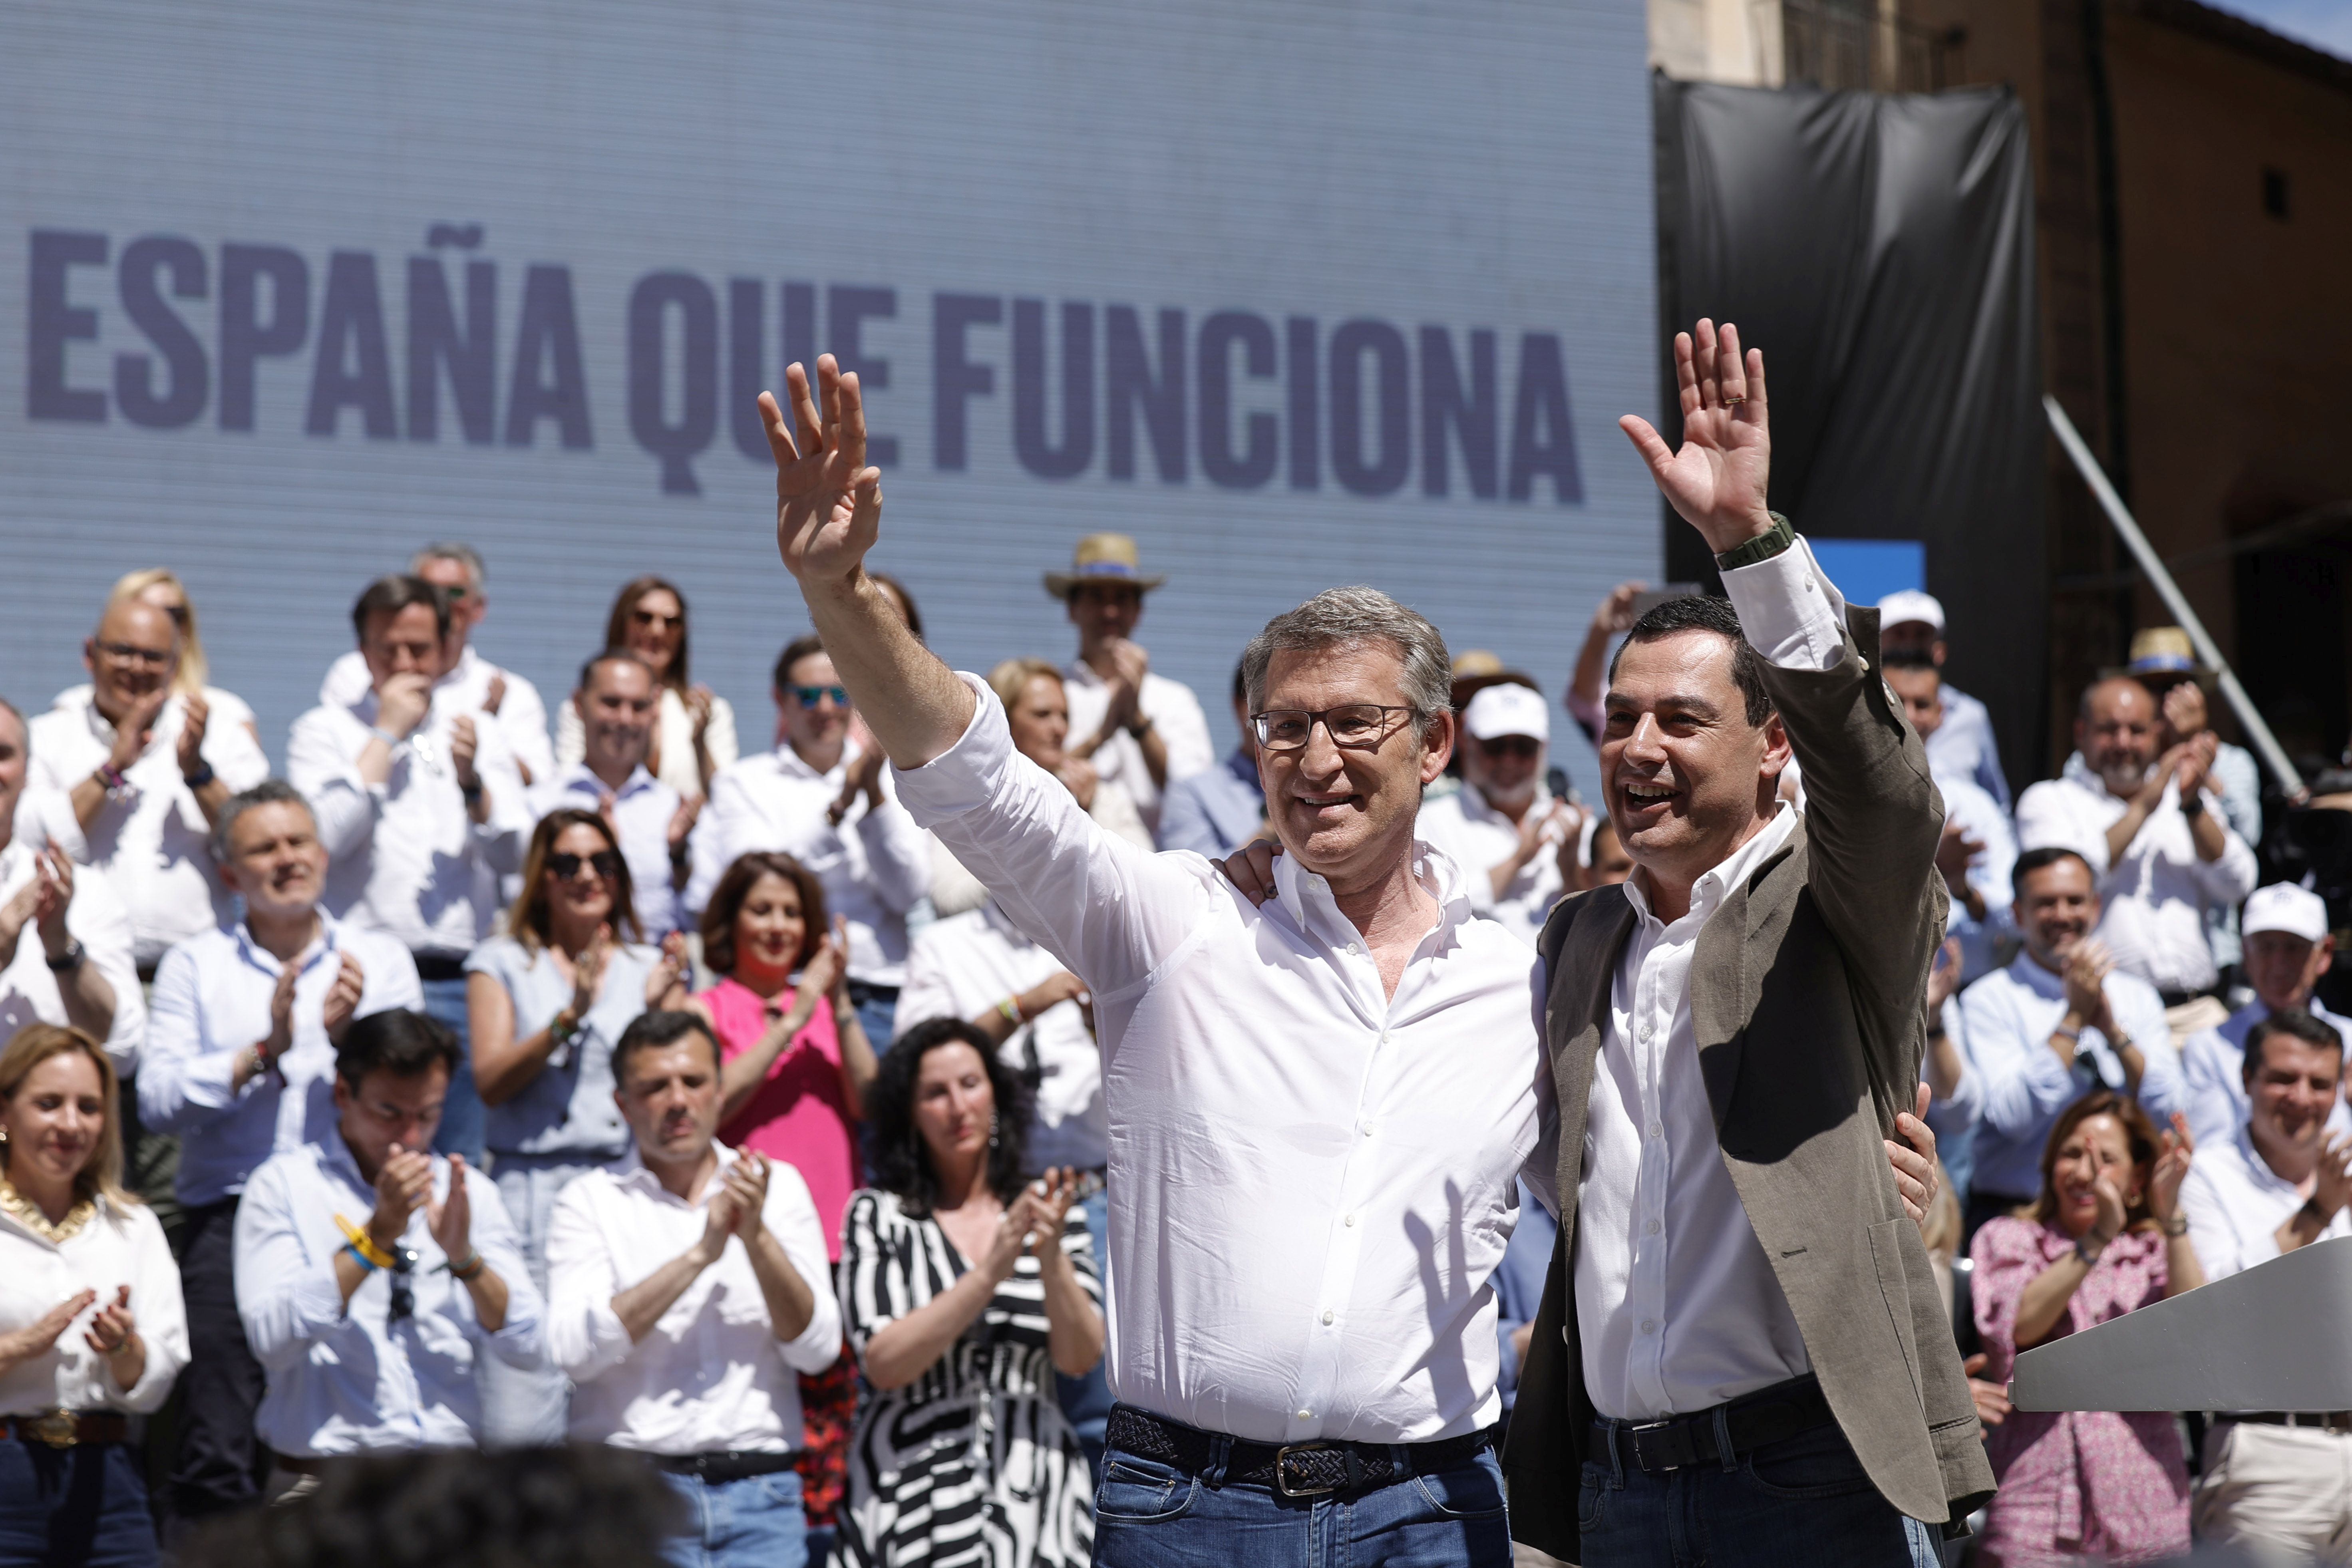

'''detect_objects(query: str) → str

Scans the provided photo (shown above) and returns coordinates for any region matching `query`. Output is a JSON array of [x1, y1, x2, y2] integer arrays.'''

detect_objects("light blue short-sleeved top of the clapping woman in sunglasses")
[[466, 936, 658, 1164]]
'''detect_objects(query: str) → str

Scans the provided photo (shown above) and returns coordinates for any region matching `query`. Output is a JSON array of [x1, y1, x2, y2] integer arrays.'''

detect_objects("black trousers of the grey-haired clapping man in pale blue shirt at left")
[[172, 1199, 268, 1518]]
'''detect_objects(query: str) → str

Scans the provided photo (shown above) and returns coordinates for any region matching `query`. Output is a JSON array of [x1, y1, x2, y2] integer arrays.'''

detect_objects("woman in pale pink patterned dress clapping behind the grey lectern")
[[1968, 1089, 2204, 1568]]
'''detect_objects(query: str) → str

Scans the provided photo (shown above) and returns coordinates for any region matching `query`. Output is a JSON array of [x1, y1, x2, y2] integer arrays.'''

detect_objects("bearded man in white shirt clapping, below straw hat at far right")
[[2018, 677, 2256, 1020]]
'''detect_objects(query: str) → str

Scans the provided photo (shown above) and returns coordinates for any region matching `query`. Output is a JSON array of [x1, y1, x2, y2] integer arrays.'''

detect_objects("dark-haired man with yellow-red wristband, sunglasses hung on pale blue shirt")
[[235, 1008, 543, 1500]]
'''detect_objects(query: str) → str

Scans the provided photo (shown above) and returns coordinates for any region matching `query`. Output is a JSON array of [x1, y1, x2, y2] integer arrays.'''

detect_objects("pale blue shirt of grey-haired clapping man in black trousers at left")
[[139, 912, 423, 1208]]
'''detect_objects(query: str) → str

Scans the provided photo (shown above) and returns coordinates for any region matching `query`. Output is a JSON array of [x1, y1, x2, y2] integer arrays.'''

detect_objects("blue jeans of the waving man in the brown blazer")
[[1576, 1422, 1943, 1568]]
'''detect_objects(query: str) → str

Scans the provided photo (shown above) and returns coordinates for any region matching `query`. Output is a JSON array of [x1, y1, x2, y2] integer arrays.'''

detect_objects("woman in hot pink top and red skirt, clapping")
[[689, 853, 880, 1563]]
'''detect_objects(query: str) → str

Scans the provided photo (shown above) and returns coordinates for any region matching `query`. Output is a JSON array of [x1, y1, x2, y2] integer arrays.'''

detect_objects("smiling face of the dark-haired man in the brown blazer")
[[1602, 630, 1787, 888]]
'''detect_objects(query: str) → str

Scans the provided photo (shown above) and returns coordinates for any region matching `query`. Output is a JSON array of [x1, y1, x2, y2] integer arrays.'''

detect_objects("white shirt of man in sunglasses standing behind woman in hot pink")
[[687, 747, 926, 985]]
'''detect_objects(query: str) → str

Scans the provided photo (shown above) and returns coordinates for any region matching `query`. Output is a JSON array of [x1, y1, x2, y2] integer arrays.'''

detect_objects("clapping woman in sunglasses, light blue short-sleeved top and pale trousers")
[[466, 809, 684, 1443]]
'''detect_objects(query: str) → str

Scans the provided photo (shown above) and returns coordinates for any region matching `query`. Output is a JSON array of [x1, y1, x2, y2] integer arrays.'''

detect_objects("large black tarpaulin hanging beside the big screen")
[[1656, 75, 2046, 785]]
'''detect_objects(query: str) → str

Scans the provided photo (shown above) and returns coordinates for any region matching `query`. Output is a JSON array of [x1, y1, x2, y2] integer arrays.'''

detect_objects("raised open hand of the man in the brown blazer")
[[1618, 320, 1771, 555]]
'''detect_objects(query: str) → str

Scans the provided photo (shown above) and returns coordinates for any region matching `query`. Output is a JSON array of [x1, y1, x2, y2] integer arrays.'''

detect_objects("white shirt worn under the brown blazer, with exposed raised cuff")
[[1576, 539, 1846, 1420]]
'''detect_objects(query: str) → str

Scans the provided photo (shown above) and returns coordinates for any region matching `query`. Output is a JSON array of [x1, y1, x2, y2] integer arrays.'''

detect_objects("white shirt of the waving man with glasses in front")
[[899, 675, 1557, 1443]]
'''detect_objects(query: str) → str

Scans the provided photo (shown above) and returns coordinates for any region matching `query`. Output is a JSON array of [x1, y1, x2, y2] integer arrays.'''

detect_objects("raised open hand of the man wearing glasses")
[[760, 355, 882, 583]]
